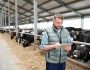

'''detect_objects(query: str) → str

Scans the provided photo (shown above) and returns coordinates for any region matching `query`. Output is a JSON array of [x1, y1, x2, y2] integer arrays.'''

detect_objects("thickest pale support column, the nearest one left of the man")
[[33, 0, 38, 42]]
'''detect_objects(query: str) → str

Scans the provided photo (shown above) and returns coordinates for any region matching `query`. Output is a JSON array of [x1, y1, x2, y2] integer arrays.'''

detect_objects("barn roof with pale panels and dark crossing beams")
[[0, 0, 90, 22]]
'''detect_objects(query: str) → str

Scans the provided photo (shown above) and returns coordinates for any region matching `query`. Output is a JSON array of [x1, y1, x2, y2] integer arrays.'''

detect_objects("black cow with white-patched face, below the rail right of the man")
[[70, 33, 90, 62]]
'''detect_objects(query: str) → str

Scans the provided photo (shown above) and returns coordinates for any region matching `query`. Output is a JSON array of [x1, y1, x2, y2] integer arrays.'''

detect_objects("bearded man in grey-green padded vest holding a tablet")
[[40, 14, 71, 70]]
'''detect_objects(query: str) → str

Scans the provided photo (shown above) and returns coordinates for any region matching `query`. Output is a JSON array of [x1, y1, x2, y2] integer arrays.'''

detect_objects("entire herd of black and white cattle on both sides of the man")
[[0, 27, 90, 62]]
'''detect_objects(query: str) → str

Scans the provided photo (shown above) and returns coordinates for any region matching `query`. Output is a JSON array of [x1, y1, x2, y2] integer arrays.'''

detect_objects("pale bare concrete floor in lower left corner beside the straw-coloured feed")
[[0, 37, 23, 70]]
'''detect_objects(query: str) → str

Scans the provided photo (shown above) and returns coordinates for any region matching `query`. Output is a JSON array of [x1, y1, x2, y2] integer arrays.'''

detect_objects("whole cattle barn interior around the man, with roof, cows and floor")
[[0, 0, 90, 70]]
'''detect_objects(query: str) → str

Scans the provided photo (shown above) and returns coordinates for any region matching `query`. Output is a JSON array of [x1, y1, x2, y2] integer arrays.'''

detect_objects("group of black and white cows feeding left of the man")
[[11, 28, 44, 47]]
